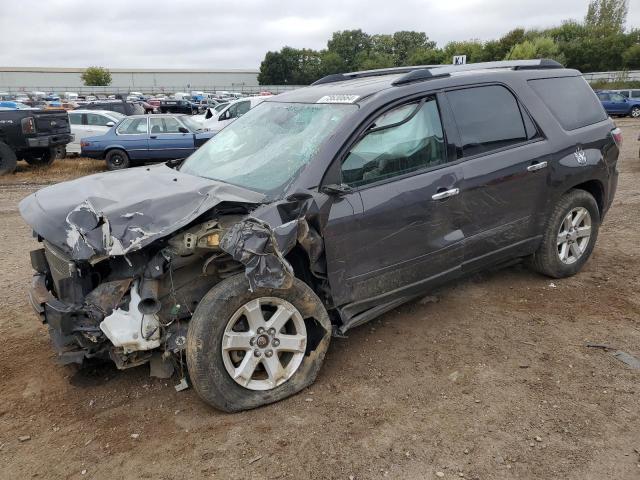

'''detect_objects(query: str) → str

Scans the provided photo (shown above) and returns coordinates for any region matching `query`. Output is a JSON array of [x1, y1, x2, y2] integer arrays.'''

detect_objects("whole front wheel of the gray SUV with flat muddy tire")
[[187, 275, 331, 412]]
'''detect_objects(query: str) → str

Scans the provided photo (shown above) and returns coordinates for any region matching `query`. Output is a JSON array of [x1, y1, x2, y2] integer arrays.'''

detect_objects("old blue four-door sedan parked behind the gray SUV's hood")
[[80, 115, 215, 170]]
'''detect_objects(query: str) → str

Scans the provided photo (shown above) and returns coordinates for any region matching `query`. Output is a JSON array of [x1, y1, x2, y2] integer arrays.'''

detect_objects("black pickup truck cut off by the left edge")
[[0, 110, 73, 175]]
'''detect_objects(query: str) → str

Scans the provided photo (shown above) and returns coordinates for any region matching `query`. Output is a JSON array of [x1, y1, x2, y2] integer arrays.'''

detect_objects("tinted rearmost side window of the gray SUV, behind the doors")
[[529, 77, 607, 130]]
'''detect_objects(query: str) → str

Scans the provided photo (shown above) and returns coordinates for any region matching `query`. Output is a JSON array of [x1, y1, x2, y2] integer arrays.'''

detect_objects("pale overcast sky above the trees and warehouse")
[[0, 0, 640, 68]]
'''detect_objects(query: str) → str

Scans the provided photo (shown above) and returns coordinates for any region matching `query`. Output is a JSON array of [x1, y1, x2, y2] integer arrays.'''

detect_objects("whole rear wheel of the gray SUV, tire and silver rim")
[[529, 190, 600, 278]]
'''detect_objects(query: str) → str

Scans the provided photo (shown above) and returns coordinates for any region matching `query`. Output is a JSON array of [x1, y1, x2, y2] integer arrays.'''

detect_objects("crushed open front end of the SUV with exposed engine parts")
[[31, 215, 250, 374]]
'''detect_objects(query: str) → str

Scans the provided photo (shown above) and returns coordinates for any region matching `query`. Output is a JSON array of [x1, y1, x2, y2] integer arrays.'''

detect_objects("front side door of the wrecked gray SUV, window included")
[[324, 98, 463, 313]]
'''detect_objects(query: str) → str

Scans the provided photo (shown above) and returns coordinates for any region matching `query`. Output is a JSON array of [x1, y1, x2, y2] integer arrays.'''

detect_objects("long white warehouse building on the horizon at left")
[[0, 67, 258, 93]]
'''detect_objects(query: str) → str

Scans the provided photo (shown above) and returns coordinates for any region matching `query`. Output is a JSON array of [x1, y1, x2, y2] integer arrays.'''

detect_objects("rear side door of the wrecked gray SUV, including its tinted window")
[[446, 84, 550, 270]]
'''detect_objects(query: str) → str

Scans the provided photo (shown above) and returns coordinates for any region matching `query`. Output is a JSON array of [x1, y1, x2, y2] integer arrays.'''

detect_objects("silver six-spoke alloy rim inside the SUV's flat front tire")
[[222, 297, 307, 390]]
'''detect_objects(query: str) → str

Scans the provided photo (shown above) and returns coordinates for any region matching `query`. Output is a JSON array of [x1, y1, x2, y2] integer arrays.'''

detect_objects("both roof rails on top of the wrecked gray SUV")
[[311, 58, 564, 86]]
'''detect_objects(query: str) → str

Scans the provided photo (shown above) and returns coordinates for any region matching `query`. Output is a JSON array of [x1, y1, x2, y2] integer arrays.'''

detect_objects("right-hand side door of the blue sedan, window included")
[[149, 116, 195, 160]]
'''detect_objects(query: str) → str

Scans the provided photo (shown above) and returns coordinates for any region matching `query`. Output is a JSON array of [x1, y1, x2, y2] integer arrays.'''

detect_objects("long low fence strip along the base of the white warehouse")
[[0, 84, 304, 95]]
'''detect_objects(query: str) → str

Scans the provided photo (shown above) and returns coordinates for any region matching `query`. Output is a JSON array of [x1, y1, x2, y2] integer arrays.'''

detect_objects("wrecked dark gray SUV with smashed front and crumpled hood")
[[20, 60, 621, 411]]
